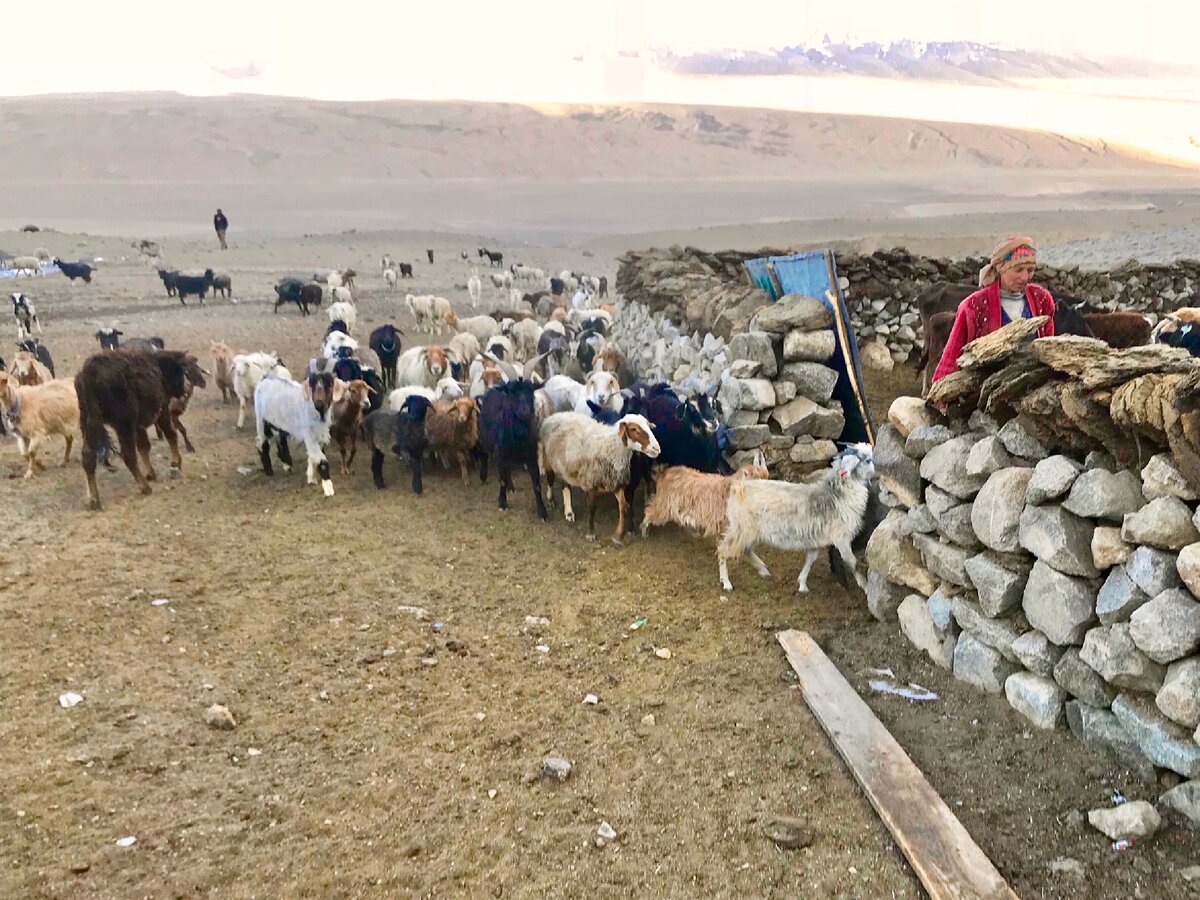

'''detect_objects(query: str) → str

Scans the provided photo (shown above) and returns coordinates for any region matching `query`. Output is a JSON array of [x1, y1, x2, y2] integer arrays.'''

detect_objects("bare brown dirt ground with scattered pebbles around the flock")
[[0, 235, 1200, 898]]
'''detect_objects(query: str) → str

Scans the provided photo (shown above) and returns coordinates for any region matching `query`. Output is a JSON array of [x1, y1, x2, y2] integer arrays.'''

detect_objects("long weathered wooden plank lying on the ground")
[[776, 631, 1016, 900]]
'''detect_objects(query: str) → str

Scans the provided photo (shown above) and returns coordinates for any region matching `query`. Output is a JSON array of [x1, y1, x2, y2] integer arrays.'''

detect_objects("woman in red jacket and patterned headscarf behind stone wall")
[[931, 234, 1054, 383]]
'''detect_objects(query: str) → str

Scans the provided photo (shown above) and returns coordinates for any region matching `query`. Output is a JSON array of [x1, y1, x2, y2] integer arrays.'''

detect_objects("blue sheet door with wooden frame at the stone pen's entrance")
[[745, 250, 875, 444]]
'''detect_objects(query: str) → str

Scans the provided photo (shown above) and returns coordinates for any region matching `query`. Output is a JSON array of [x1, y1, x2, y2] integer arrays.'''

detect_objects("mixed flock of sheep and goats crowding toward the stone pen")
[[0, 248, 874, 592]]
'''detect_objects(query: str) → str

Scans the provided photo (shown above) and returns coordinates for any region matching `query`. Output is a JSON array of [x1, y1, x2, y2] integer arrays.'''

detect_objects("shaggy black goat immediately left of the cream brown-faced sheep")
[[479, 378, 546, 522]]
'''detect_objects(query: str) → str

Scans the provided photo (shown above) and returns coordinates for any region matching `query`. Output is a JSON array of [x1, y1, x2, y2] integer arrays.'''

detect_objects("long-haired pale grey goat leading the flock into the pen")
[[716, 444, 875, 594]]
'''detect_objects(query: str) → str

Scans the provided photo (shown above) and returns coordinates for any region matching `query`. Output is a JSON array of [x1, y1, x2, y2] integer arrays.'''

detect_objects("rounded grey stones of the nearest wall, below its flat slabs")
[[866, 397, 1200, 823]]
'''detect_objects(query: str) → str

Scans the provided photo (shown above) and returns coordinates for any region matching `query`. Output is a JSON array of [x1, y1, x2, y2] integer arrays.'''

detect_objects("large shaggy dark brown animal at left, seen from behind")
[[74, 350, 196, 509]]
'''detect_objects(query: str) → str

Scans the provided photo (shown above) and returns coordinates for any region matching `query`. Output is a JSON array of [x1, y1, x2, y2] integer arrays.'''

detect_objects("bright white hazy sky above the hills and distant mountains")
[[0, 0, 1200, 101]]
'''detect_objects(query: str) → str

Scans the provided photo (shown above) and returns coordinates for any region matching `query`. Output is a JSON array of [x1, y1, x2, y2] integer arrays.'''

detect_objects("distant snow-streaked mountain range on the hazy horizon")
[[653, 37, 1190, 83]]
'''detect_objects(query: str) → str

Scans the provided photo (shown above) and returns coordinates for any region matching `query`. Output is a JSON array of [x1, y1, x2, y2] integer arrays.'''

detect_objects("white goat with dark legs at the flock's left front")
[[254, 372, 334, 497]]
